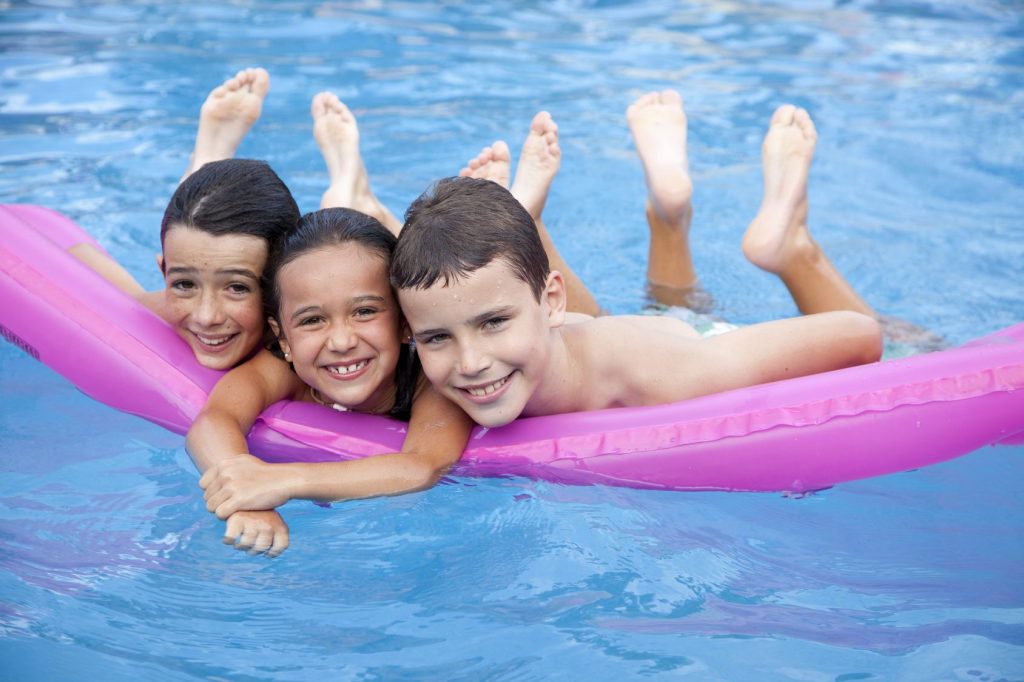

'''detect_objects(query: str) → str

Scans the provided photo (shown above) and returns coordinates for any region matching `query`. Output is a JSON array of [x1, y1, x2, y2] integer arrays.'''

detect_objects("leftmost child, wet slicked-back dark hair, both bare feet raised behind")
[[55, 69, 399, 370]]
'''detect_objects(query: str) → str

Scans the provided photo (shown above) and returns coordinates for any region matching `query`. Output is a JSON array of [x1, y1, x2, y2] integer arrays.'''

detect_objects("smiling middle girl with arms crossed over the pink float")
[[187, 209, 472, 556]]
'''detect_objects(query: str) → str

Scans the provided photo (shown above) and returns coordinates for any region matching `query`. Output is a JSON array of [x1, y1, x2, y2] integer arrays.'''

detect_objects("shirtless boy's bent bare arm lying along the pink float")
[[633, 311, 882, 404]]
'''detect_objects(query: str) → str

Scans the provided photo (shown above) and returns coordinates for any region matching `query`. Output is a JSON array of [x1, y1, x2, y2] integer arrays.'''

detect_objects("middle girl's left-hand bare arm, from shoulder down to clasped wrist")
[[185, 350, 302, 472]]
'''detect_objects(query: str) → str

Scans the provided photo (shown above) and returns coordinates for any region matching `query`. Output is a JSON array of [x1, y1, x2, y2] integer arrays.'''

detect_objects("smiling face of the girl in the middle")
[[270, 242, 403, 413]]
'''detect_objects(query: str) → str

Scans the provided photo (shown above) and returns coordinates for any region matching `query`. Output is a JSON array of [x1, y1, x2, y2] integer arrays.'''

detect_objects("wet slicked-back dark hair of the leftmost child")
[[160, 159, 299, 245]]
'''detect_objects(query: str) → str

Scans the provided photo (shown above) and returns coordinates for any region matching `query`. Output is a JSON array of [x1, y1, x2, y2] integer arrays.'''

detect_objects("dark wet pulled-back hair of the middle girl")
[[263, 208, 420, 421]]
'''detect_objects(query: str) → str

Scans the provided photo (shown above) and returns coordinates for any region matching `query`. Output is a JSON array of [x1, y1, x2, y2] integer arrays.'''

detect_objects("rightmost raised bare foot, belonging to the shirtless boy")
[[742, 104, 818, 274]]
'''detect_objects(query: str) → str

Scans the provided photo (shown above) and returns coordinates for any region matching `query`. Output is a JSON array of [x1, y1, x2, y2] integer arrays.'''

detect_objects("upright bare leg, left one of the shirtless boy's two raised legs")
[[626, 90, 697, 305]]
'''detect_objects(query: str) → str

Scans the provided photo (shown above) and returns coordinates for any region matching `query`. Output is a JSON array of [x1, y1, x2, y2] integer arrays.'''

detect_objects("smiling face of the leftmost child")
[[161, 225, 267, 370]]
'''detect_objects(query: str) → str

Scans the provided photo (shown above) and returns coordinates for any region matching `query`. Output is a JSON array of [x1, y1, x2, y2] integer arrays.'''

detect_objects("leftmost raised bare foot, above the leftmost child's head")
[[185, 69, 270, 177]]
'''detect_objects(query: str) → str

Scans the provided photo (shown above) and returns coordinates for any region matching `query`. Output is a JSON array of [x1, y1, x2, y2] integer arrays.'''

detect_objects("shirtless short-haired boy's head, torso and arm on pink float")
[[391, 177, 882, 427]]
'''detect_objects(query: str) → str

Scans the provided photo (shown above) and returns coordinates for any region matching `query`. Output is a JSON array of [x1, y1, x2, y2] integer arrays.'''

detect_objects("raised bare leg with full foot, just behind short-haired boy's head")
[[511, 112, 601, 315]]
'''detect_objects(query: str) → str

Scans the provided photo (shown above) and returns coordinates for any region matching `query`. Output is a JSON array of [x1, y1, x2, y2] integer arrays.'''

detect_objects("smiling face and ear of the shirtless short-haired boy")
[[398, 259, 565, 427]]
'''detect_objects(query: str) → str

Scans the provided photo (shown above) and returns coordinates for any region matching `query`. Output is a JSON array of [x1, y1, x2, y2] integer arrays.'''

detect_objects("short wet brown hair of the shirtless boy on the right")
[[391, 177, 550, 301]]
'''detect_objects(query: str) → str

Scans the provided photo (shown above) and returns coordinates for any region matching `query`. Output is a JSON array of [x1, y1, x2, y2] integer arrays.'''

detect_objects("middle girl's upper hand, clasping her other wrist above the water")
[[199, 455, 290, 519]]
